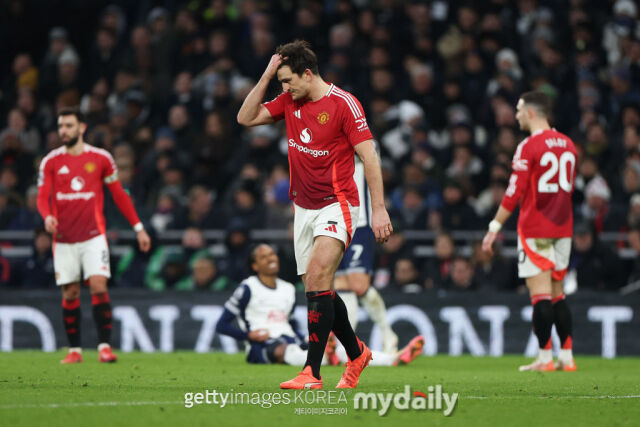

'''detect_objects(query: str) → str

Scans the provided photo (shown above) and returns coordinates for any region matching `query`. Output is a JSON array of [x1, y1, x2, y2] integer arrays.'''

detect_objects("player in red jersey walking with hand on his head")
[[238, 40, 393, 389]]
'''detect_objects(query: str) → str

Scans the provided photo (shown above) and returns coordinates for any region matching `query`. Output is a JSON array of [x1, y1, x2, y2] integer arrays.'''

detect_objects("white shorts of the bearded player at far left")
[[53, 234, 111, 286]]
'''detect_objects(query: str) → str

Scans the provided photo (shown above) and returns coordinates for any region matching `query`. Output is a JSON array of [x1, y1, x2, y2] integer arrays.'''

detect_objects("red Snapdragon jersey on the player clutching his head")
[[263, 84, 373, 209]]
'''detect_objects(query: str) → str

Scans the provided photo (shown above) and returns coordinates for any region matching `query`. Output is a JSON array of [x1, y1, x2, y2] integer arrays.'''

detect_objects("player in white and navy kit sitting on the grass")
[[216, 244, 420, 366]]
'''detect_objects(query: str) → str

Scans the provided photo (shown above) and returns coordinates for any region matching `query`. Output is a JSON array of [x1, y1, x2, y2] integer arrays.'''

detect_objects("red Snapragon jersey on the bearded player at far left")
[[38, 143, 118, 243]]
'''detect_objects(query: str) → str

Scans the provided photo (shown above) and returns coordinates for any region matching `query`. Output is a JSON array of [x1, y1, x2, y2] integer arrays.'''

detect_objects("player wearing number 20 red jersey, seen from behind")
[[482, 92, 577, 371]]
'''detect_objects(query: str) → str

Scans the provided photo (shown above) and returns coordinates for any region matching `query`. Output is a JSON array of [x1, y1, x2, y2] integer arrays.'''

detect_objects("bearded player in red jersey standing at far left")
[[38, 108, 151, 363]]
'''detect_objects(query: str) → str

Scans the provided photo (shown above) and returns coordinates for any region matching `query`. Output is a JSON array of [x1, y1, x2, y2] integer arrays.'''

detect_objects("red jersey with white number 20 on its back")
[[502, 129, 577, 238]]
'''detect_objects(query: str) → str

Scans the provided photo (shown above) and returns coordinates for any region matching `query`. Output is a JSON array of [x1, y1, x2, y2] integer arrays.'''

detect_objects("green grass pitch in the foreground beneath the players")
[[0, 351, 640, 427]]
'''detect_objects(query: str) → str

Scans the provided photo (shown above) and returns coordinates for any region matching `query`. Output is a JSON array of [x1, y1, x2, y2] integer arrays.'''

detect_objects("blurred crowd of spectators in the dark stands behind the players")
[[0, 0, 640, 292]]
